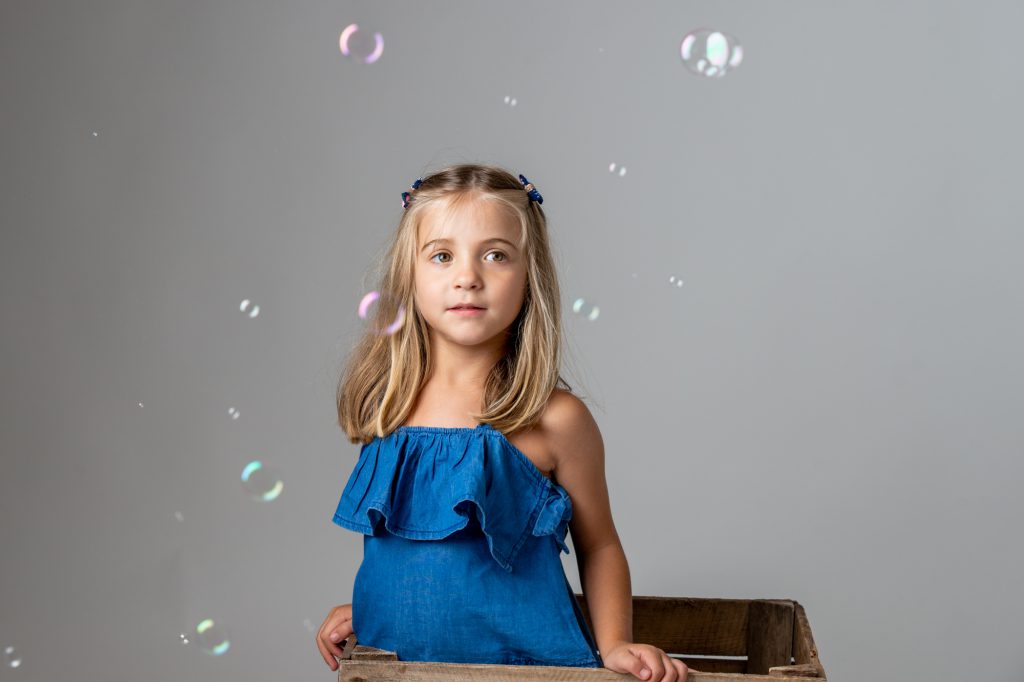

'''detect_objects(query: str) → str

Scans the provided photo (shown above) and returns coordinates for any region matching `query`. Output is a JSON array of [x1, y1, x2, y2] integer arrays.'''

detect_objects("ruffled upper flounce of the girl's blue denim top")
[[334, 424, 572, 572]]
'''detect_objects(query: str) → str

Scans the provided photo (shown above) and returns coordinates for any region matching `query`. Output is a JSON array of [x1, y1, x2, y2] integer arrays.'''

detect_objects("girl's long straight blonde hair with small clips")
[[337, 164, 585, 443]]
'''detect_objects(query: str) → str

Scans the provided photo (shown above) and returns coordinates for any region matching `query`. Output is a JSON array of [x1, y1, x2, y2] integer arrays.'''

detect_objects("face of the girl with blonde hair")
[[415, 193, 526, 346]]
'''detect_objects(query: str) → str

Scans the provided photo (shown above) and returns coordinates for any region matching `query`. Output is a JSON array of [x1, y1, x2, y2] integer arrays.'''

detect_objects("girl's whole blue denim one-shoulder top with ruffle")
[[334, 424, 603, 668]]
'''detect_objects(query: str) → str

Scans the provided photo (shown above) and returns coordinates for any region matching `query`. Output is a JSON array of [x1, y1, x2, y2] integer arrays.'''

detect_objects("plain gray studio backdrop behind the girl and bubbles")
[[0, 0, 1024, 682]]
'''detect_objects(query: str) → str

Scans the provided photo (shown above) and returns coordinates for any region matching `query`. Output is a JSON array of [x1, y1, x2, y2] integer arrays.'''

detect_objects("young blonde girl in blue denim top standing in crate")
[[316, 164, 687, 682]]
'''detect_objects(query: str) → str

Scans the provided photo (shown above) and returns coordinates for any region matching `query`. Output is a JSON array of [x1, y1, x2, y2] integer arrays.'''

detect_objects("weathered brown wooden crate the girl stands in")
[[338, 594, 826, 682]]
